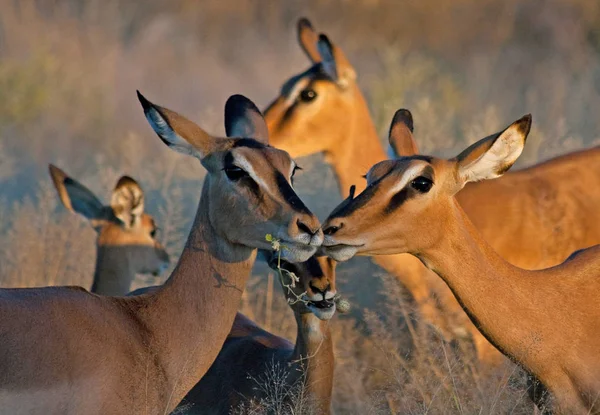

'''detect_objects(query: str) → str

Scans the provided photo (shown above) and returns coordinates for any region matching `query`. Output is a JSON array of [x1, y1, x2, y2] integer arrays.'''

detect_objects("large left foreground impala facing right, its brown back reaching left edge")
[[0, 93, 323, 414]]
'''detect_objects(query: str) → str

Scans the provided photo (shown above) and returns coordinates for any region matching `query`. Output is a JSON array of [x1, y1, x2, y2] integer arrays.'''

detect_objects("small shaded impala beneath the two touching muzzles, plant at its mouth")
[[179, 257, 336, 415]]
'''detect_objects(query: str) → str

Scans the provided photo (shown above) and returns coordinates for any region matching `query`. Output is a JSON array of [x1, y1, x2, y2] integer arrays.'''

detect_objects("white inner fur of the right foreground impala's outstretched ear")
[[460, 127, 524, 182]]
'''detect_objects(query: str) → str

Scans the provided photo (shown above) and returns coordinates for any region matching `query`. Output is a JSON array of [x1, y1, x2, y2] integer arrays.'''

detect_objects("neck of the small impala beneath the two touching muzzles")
[[292, 313, 334, 414]]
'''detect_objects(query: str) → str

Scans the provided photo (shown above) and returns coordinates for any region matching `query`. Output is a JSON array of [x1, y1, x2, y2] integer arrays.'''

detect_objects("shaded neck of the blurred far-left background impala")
[[91, 246, 135, 296]]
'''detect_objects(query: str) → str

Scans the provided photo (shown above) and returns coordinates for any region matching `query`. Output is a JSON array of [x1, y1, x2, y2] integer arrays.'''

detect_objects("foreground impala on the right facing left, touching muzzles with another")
[[324, 116, 600, 414]]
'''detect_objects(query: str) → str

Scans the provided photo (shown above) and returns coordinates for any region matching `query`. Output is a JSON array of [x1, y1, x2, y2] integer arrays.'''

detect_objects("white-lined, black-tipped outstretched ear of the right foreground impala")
[[455, 114, 531, 185]]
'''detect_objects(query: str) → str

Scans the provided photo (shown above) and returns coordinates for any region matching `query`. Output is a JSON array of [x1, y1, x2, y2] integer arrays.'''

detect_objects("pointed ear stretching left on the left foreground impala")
[[137, 91, 223, 160]]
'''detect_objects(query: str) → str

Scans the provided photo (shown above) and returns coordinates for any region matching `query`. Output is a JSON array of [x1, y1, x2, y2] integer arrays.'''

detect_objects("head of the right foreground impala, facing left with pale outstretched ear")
[[323, 115, 531, 261]]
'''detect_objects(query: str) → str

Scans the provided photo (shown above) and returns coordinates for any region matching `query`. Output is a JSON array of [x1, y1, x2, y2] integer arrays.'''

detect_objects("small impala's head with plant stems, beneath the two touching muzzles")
[[268, 253, 337, 320]]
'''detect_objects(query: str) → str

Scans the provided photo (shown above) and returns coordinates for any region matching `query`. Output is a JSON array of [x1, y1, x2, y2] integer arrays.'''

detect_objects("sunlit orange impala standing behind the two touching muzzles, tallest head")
[[265, 19, 600, 363]]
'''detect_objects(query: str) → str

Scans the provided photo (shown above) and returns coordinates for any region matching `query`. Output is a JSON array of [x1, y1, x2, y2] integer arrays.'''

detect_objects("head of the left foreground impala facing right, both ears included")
[[138, 92, 323, 261]]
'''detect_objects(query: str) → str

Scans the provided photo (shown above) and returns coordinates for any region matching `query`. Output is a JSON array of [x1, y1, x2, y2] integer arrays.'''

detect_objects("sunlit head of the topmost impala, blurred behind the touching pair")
[[265, 19, 363, 157]]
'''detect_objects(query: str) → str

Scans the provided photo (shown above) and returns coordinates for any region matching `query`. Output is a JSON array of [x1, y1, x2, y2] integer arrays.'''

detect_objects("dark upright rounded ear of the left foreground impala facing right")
[[225, 95, 269, 144]]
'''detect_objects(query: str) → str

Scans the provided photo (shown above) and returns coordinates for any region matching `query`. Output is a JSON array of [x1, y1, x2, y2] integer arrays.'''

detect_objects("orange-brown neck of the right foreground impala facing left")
[[417, 200, 540, 363]]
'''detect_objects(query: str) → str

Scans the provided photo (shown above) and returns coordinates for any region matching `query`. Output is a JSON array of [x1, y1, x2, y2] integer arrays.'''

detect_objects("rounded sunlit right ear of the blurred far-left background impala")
[[110, 176, 144, 228]]
